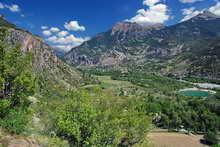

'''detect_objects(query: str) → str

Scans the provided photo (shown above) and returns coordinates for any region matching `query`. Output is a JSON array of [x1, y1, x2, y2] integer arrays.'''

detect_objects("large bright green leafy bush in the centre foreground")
[[56, 90, 149, 147]]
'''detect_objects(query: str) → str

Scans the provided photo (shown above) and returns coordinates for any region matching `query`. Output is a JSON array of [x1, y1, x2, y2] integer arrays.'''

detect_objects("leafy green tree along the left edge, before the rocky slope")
[[0, 28, 36, 134]]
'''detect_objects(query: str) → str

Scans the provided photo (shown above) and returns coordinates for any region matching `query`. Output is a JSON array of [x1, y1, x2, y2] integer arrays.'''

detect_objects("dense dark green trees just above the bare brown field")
[[139, 96, 220, 134]]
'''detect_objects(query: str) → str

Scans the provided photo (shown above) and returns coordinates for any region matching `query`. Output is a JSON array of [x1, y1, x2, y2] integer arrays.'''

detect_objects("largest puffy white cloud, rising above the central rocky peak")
[[127, 0, 170, 25]]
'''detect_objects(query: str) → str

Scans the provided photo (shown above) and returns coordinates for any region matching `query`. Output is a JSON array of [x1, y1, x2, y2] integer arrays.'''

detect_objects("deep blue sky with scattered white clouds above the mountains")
[[0, 0, 220, 51]]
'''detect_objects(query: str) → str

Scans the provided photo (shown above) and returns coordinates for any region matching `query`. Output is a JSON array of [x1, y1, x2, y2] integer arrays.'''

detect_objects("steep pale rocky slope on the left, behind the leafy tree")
[[0, 18, 83, 88]]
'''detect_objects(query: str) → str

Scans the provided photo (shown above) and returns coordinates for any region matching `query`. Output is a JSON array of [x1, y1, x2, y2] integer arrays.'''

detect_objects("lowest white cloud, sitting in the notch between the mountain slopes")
[[47, 34, 89, 51]]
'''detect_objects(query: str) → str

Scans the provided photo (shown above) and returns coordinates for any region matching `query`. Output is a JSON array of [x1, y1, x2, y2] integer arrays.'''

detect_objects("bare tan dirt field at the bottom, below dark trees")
[[148, 133, 207, 147]]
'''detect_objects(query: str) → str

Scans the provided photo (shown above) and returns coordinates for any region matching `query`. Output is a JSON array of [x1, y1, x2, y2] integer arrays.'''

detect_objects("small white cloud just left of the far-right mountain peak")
[[181, 7, 202, 22]]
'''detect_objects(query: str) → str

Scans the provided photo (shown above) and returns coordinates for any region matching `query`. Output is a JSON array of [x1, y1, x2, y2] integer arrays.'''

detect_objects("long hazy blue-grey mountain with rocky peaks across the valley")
[[65, 11, 220, 78]]
